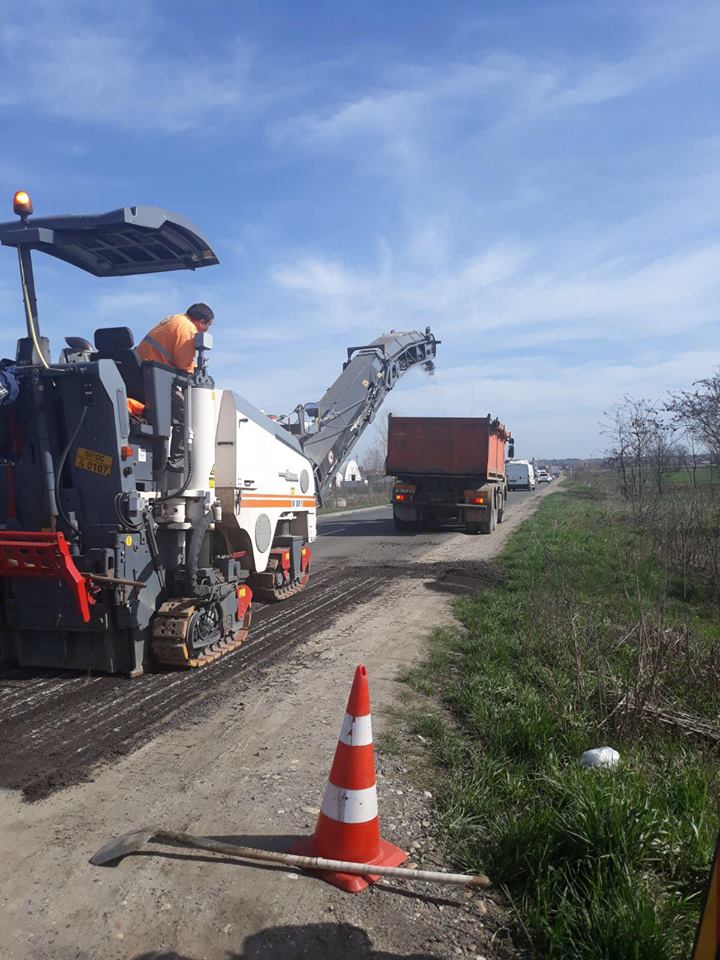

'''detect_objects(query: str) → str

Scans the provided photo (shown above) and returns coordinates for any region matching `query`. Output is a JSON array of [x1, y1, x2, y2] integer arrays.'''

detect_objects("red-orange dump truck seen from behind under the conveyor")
[[385, 415, 514, 533]]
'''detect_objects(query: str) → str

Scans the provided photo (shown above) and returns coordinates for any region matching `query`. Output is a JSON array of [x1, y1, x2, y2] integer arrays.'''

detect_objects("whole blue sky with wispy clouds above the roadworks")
[[0, 0, 720, 457]]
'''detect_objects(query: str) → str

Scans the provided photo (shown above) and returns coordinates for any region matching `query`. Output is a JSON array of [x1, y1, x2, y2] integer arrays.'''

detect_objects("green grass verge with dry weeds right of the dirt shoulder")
[[409, 485, 720, 960]]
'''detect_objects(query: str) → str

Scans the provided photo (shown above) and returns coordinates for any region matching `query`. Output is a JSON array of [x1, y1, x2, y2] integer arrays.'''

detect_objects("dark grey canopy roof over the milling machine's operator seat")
[[0, 206, 219, 277]]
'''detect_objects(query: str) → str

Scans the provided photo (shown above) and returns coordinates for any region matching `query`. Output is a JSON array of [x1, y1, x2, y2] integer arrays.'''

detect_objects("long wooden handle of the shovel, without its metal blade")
[[152, 830, 490, 888]]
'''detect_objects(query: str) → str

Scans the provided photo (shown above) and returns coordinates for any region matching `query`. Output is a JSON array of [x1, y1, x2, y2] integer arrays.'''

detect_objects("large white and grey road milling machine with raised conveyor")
[[0, 192, 437, 676]]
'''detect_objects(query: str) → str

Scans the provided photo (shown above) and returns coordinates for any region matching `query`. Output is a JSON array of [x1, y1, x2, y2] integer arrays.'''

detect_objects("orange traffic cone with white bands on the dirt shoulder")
[[290, 666, 408, 893]]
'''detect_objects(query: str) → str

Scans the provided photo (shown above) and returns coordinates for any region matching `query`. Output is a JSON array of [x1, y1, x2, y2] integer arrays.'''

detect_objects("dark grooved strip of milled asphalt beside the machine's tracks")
[[0, 568, 392, 800]]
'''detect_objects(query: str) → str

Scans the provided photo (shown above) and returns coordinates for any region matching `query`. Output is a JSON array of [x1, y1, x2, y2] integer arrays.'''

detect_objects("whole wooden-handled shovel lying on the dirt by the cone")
[[90, 826, 490, 888]]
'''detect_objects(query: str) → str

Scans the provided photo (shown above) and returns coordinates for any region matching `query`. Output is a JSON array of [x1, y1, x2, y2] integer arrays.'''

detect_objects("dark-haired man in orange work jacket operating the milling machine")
[[137, 303, 215, 473]]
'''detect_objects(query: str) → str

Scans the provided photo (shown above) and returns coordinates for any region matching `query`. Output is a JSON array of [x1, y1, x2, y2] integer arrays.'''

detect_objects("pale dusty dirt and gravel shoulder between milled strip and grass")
[[0, 491, 550, 960]]
